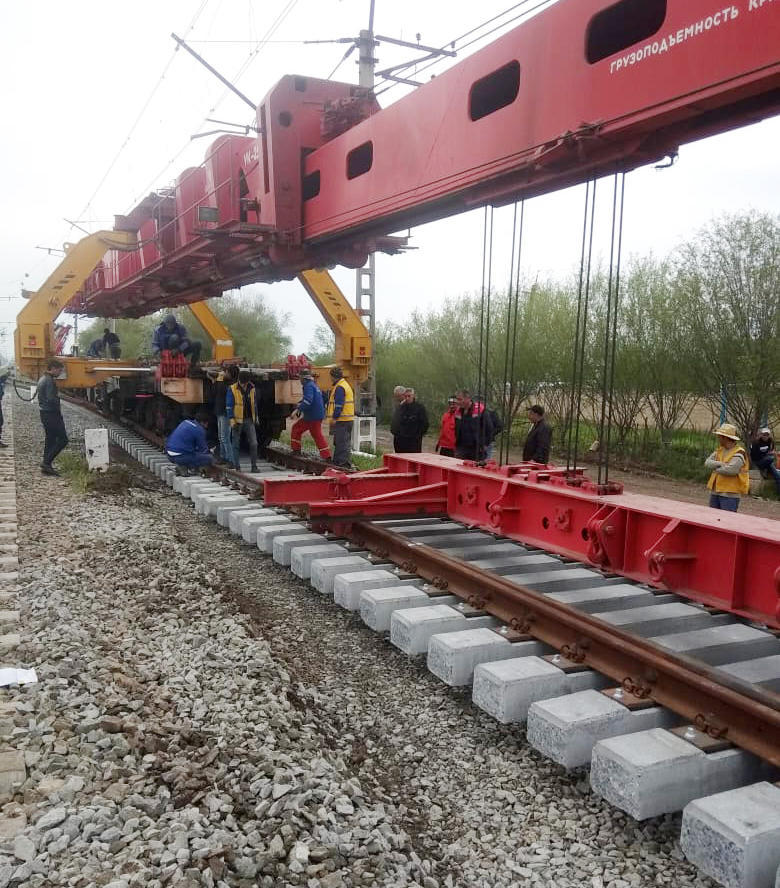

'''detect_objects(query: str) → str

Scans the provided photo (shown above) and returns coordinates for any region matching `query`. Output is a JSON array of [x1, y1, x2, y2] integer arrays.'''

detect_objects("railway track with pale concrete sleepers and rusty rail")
[[62, 400, 780, 888]]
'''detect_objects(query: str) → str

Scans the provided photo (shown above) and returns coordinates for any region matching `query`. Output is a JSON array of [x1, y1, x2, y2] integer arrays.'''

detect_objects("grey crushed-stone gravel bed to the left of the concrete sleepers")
[[0, 402, 713, 888]]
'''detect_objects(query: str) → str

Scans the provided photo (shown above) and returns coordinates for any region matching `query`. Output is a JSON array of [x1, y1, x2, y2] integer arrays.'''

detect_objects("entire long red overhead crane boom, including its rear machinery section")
[[72, 0, 780, 316]]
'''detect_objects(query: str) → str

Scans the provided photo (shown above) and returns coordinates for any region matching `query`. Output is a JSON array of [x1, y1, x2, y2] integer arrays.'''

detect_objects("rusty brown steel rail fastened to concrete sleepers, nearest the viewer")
[[340, 519, 780, 766]]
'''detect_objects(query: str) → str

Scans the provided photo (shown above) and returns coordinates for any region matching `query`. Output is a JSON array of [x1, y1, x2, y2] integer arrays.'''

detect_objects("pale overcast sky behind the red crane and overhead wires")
[[0, 0, 780, 354]]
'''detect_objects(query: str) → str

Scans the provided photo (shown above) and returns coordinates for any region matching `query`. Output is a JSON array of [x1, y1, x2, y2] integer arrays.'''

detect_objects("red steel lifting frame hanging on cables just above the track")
[[265, 453, 780, 628]]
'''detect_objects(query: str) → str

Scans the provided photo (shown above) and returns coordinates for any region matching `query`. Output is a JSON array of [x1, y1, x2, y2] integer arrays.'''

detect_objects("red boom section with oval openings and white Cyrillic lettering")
[[303, 0, 780, 244]]
